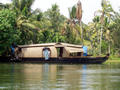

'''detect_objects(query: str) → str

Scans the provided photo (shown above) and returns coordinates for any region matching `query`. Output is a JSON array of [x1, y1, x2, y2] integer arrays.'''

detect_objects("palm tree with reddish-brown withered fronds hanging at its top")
[[67, 1, 83, 44]]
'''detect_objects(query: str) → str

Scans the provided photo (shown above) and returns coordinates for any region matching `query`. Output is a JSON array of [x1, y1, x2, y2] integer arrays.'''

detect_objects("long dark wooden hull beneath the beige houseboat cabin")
[[0, 57, 108, 64]]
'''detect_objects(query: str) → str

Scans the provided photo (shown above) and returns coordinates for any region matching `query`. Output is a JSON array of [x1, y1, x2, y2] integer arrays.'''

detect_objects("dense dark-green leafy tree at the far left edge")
[[0, 9, 19, 54]]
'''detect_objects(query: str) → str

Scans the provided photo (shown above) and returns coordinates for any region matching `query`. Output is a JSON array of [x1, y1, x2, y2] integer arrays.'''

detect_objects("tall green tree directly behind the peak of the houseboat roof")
[[45, 4, 66, 42]]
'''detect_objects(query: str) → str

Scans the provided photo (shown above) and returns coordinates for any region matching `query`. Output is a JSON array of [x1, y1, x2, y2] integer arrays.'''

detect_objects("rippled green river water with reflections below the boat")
[[0, 64, 120, 90]]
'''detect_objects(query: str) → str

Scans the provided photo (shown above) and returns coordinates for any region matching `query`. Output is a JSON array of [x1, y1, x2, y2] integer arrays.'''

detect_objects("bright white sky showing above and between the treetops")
[[0, 0, 120, 24]]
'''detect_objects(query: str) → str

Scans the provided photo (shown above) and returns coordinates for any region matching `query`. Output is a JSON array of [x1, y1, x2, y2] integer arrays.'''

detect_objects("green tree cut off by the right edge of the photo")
[[110, 12, 120, 56]]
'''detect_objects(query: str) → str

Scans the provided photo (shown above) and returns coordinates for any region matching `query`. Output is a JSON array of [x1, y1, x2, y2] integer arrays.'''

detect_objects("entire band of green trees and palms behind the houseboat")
[[0, 0, 120, 57]]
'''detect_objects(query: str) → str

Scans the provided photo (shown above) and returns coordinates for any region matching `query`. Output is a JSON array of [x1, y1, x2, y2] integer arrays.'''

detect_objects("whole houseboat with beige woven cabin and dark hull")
[[4, 43, 109, 64]]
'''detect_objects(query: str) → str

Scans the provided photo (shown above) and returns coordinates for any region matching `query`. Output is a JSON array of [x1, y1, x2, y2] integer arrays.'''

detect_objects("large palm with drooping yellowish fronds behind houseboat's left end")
[[12, 0, 40, 44]]
